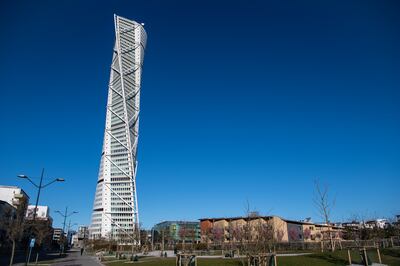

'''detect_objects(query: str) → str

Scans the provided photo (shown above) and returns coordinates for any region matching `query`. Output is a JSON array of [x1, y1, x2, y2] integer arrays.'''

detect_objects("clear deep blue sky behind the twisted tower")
[[0, 0, 400, 228]]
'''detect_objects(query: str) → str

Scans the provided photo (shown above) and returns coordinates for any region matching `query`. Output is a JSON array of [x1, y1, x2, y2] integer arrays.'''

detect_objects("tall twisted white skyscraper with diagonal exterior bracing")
[[90, 15, 147, 243]]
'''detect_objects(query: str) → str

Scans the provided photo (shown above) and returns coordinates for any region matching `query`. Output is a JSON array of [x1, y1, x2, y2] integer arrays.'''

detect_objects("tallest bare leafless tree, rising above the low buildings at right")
[[314, 180, 335, 251]]
